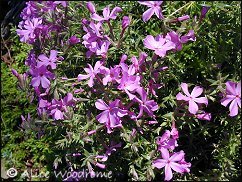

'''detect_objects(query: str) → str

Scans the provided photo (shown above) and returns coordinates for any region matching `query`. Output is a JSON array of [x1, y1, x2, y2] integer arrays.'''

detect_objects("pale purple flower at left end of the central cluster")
[[78, 61, 102, 87]]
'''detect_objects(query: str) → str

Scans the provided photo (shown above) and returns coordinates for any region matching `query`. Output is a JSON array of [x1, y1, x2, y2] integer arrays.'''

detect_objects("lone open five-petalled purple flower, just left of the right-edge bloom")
[[176, 83, 208, 114]]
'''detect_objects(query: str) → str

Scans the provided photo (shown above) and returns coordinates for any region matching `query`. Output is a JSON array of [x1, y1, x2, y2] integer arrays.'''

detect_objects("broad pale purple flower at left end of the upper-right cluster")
[[144, 35, 176, 57]]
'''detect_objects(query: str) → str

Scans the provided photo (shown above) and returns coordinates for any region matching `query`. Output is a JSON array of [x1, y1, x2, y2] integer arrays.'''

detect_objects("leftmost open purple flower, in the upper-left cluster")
[[16, 18, 42, 44]]
